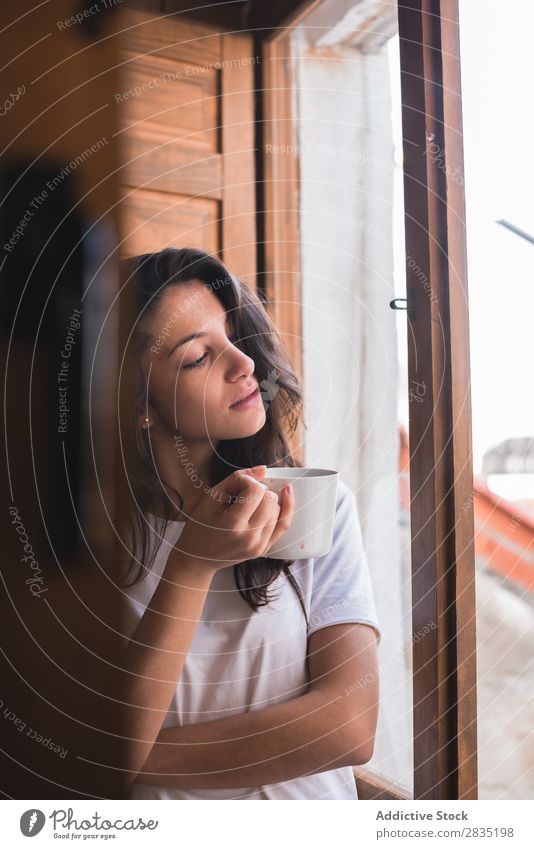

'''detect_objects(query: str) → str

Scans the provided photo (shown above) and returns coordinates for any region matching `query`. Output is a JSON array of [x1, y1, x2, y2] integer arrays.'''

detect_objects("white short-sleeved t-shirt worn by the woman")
[[123, 481, 381, 799]]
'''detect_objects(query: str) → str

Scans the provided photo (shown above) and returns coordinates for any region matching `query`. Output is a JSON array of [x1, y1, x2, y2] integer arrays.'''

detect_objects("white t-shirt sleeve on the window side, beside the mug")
[[308, 481, 381, 643]]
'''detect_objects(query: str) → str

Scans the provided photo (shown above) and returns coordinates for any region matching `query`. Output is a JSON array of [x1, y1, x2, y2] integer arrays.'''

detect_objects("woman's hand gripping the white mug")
[[171, 466, 294, 572]]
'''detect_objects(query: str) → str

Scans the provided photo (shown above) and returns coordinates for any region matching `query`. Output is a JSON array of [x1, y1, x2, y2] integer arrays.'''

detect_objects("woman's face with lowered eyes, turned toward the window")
[[143, 281, 266, 443]]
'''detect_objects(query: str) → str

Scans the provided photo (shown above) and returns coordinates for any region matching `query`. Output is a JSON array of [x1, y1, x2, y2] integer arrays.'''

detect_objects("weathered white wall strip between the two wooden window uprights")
[[292, 3, 418, 795]]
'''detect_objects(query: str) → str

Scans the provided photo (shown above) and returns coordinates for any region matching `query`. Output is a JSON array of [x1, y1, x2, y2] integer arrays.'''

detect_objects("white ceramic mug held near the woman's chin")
[[261, 466, 339, 560]]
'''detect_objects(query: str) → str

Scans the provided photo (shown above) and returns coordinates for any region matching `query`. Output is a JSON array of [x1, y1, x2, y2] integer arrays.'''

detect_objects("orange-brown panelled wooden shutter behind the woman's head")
[[118, 10, 256, 288]]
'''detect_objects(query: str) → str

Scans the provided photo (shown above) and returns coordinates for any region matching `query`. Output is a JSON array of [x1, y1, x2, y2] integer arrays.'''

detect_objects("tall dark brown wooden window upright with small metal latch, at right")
[[399, 0, 477, 799]]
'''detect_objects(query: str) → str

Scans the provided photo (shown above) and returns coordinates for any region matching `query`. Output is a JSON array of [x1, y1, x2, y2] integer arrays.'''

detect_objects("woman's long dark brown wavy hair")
[[121, 248, 307, 619]]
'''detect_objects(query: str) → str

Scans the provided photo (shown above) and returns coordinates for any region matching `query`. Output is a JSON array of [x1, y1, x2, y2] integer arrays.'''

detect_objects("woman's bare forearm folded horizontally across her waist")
[[136, 690, 357, 789]]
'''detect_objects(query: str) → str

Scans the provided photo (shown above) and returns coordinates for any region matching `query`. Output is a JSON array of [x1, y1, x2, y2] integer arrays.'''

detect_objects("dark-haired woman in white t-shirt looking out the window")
[[119, 243, 380, 799]]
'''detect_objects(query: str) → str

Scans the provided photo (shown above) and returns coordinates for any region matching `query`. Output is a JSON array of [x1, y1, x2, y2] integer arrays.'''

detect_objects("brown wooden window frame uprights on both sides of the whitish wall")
[[258, 0, 477, 799]]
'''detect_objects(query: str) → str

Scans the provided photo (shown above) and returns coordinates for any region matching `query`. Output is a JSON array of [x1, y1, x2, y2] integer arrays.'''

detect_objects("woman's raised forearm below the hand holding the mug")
[[119, 553, 213, 786]]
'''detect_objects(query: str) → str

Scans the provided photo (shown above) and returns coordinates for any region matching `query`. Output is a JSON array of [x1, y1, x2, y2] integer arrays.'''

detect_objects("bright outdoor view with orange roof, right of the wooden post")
[[460, 0, 534, 799]]
